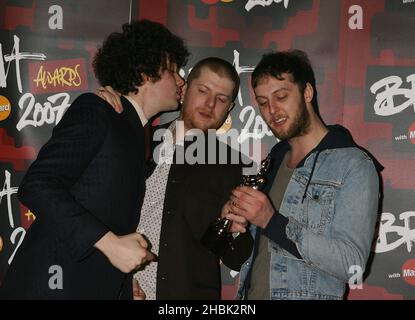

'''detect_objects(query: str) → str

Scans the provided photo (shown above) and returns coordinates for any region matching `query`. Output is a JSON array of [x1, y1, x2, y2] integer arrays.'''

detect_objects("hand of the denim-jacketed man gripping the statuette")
[[230, 186, 276, 229]]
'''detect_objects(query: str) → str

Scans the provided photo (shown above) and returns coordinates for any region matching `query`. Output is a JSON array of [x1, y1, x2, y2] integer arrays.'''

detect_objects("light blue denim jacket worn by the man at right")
[[237, 126, 379, 299]]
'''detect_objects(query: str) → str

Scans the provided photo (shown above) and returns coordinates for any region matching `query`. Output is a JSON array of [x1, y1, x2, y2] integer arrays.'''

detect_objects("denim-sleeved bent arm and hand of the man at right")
[[231, 158, 379, 282]]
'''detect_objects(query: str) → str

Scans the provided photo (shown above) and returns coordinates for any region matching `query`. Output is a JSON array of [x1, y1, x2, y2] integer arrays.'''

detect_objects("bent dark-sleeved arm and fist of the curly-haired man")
[[18, 94, 155, 272]]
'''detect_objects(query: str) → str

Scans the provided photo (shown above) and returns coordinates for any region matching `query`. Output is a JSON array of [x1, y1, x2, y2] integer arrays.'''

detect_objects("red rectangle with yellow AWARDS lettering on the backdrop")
[[29, 59, 88, 94]]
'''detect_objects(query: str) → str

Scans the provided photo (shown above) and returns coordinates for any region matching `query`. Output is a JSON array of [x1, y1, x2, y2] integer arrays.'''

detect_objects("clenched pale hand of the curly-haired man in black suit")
[[95, 231, 155, 273]]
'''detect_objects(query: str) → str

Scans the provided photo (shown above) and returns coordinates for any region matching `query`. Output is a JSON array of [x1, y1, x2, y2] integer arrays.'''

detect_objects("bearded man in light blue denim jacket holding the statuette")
[[222, 50, 381, 299]]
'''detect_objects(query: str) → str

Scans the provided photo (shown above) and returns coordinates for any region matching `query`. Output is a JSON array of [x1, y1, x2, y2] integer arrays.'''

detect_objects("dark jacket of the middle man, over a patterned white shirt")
[[153, 126, 252, 300]]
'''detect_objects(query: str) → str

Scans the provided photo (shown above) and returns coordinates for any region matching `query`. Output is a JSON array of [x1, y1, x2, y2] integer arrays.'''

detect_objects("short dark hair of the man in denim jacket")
[[252, 49, 323, 120]]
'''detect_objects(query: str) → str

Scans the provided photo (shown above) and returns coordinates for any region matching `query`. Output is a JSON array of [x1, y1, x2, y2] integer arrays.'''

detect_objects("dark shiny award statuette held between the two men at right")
[[200, 155, 271, 256]]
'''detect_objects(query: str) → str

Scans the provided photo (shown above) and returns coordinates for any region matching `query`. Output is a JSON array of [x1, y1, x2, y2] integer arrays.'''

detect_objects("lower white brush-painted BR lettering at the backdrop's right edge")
[[375, 211, 415, 253]]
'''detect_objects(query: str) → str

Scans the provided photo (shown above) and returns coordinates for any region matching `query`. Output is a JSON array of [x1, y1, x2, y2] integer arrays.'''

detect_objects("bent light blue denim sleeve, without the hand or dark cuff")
[[286, 157, 379, 282]]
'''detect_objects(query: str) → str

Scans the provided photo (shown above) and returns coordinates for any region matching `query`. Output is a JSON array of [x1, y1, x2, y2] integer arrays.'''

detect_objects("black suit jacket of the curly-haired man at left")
[[0, 93, 145, 299]]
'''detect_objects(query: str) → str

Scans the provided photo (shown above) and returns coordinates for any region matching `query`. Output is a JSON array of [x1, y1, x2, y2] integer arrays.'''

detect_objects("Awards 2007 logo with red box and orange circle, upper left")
[[0, 35, 75, 131]]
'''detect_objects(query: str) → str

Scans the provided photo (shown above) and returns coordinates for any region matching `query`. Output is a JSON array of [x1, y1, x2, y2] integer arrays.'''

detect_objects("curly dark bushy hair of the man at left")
[[92, 20, 189, 94]]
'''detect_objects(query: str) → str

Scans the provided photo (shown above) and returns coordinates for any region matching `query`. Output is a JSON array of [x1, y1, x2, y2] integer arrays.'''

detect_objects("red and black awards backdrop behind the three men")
[[0, 0, 415, 299]]
